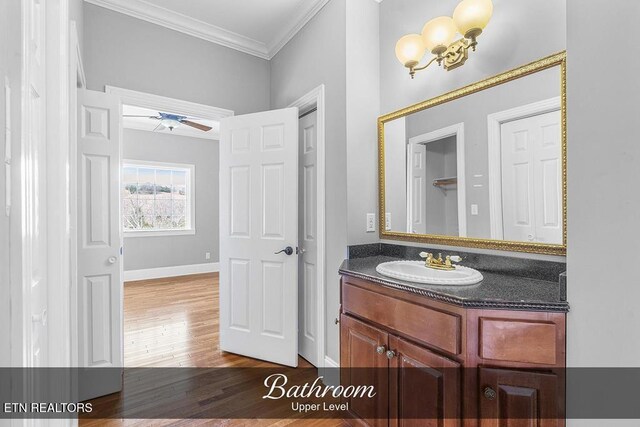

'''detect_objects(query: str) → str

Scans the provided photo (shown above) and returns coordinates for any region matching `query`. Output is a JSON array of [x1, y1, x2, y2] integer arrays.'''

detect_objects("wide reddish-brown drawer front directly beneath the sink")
[[342, 282, 461, 355]]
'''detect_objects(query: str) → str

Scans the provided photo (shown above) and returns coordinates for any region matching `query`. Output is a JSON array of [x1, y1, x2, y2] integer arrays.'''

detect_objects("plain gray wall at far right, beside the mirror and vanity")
[[567, 0, 640, 427]]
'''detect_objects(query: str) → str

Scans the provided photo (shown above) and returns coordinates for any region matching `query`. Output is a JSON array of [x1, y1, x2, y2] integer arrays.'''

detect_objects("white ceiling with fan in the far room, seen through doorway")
[[122, 105, 220, 140]]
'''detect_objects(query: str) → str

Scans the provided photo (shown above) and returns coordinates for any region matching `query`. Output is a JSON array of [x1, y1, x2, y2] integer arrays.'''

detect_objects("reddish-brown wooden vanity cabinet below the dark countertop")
[[340, 276, 565, 427]]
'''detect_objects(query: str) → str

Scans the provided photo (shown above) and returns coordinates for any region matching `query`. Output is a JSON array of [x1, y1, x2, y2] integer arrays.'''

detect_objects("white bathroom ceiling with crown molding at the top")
[[85, 0, 336, 59]]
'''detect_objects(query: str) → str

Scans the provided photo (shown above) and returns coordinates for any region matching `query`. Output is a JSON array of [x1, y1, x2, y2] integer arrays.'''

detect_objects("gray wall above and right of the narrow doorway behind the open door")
[[271, 0, 350, 361]]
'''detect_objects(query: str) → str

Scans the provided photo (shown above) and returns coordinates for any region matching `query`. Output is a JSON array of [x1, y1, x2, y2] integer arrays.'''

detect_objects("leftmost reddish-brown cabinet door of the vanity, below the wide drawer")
[[340, 314, 389, 427]]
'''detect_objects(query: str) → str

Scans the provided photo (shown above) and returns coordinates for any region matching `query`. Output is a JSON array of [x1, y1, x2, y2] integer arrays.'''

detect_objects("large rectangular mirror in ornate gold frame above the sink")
[[378, 52, 567, 255]]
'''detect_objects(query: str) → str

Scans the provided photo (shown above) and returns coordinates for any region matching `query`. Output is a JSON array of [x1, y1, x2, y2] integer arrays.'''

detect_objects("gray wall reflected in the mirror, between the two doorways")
[[404, 67, 560, 239]]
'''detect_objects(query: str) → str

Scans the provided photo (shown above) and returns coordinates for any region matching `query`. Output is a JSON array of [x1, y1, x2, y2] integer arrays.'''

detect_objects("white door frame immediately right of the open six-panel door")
[[288, 84, 333, 368]]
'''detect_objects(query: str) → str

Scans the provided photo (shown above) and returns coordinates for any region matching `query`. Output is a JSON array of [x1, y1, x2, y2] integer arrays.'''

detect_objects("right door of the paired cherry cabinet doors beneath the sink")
[[389, 336, 461, 427]]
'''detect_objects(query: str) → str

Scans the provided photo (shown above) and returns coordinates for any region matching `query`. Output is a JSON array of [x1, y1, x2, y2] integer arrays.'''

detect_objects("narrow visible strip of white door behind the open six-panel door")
[[298, 111, 319, 366]]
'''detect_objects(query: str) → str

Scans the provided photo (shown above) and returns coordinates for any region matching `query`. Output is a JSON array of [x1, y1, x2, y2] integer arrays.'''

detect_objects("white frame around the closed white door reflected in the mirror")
[[487, 96, 561, 240]]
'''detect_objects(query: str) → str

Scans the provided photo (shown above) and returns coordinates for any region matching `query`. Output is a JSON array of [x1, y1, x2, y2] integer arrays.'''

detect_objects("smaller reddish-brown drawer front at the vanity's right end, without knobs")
[[478, 317, 558, 365]]
